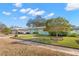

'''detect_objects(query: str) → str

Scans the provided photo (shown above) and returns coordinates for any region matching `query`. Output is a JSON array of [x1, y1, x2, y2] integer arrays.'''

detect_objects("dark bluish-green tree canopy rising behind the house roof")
[[26, 15, 46, 27]]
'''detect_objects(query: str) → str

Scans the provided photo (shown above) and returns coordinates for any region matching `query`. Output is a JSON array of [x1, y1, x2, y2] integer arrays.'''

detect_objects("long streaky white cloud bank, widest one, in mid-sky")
[[20, 8, 45, 16]]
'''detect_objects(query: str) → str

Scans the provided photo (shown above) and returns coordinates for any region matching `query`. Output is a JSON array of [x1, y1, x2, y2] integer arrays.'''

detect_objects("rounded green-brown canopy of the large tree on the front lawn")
[[45, 17, 71, 34]]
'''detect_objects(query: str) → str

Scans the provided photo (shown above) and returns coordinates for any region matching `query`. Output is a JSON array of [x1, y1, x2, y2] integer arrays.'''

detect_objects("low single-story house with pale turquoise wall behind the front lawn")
[[11, 27, 48, 35]]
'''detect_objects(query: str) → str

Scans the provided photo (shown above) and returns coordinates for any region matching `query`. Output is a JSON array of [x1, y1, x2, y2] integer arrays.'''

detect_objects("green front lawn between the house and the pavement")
[[15, 34, 79, 48]]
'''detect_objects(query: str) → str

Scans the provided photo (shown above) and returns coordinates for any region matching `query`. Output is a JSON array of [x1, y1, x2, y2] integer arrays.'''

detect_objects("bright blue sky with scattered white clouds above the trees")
[[0, 3, 79, 27]]
